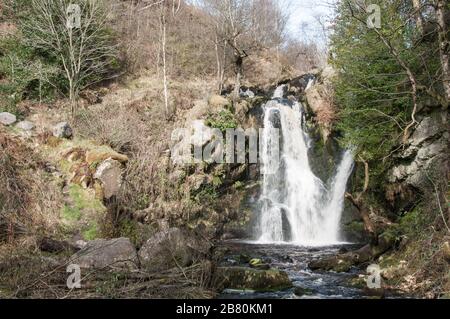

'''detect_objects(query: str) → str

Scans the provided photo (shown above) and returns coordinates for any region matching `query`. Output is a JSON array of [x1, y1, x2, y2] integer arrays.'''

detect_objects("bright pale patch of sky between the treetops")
[[280, 0, 333, 42]]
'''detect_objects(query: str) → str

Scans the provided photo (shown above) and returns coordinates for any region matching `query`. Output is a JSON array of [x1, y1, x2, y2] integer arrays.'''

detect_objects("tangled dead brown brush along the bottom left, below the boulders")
[[0, 246, 214, 299]]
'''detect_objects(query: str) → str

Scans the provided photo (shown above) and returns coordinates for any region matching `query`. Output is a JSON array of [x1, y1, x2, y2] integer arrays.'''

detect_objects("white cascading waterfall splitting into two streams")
[[258, 86, 353, 246]]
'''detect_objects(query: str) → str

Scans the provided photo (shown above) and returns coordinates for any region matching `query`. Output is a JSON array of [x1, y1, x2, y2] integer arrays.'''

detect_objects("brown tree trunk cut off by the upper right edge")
[[436, 0, 450, 101]]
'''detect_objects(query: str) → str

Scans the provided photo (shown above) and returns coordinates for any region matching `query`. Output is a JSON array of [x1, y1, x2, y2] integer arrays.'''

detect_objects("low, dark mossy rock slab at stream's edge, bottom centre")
[[214, 267, 292, 291]]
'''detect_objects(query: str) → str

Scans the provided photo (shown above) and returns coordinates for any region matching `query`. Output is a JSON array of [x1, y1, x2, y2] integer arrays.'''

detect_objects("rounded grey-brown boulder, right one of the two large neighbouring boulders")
[[139, 228, 211, 271]]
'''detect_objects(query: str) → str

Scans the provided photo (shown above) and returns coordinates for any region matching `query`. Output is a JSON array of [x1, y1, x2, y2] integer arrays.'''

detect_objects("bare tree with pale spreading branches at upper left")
[[23, 0, 117, 114]]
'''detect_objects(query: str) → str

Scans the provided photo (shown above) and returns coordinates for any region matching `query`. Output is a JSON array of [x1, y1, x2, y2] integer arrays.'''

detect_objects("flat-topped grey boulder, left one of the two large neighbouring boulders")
[[71, 238, 139, 270]]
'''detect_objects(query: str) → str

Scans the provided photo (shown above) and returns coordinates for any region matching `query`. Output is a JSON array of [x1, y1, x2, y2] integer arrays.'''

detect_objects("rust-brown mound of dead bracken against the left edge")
[[0, 128, 60, 242]]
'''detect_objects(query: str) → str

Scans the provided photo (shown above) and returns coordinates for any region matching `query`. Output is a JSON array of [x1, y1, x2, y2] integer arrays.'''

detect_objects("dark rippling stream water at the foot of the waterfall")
[[219, 241, 380, 299]]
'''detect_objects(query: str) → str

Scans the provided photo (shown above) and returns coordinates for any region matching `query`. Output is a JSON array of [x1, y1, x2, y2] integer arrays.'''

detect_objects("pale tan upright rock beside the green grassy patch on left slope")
[[94, 159, 122, 199]]
